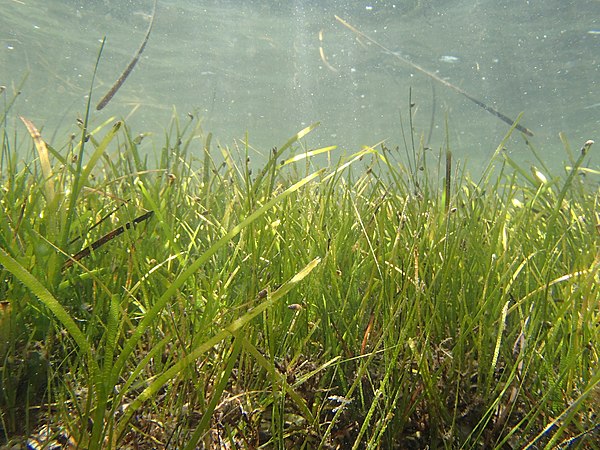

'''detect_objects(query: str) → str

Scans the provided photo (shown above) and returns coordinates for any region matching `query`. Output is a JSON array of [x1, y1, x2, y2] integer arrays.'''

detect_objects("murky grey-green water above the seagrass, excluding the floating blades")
[[0, 0, 600, 167]]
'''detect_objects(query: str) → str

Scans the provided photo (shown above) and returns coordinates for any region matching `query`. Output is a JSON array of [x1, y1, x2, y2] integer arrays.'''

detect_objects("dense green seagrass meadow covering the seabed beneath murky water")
[[0, 86, 600, 449]]
